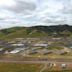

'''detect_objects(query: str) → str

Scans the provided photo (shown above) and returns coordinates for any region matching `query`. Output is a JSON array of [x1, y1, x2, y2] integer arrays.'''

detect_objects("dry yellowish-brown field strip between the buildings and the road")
[[0, 54, 72, 61]]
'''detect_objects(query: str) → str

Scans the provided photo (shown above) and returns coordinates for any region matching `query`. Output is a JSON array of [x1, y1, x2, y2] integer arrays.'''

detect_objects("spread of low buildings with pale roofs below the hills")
[[0, 38, 72, 55]]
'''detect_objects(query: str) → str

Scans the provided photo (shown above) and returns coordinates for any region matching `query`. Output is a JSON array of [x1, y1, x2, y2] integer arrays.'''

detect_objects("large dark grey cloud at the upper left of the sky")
[[7, 0, 36, 14]]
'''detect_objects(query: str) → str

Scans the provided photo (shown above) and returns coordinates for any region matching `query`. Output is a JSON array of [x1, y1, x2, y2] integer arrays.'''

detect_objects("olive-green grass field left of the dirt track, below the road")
[[0, 63, 41, 72]]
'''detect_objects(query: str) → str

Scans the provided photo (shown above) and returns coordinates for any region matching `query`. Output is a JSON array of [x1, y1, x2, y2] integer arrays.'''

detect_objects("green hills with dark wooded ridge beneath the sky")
[[0, 25, 72, 39]]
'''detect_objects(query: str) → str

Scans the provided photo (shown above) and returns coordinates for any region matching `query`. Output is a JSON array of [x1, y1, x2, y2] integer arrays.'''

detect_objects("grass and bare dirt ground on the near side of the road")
[[0, 62, 72, 72]]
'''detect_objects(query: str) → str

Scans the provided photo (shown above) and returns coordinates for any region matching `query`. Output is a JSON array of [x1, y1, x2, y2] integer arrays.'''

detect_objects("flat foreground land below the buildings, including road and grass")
[[0, 56, 72, 72]]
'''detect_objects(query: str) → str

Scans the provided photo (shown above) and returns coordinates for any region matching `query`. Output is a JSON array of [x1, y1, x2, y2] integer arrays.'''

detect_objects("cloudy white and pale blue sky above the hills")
[[0, 0, 72, 28]]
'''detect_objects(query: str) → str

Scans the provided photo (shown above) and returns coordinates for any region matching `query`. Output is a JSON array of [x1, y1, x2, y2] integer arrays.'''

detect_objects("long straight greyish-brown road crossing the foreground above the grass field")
[[0, 60, 72, 64]]
